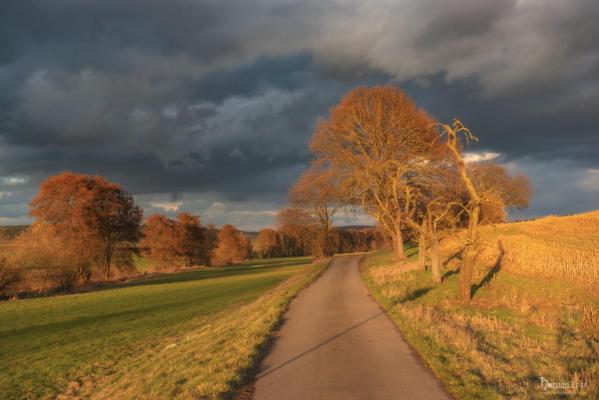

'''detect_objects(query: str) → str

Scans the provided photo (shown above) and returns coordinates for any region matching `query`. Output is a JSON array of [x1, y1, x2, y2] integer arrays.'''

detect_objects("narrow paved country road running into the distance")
[[254, 255, 449, 400]]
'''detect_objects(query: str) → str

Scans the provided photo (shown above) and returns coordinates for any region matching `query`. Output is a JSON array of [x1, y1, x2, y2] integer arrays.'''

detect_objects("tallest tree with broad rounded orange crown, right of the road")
[[310, 87, 438, 259]]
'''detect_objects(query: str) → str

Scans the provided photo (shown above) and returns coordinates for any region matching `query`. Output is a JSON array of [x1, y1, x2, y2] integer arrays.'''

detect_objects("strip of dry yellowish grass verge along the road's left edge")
[[59, 263, 325, 399]]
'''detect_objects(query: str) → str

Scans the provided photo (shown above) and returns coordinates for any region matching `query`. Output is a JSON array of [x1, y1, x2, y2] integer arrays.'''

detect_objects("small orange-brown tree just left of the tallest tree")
[[289, 164, 342, 258]]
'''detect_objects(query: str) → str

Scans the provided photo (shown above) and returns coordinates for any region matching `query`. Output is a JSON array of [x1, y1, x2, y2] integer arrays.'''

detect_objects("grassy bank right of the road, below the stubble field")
[[362, 249, 599, 399]]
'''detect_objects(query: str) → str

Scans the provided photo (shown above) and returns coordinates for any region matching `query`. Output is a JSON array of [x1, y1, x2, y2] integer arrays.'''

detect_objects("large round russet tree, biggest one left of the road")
[[30, 172, 142, 279]]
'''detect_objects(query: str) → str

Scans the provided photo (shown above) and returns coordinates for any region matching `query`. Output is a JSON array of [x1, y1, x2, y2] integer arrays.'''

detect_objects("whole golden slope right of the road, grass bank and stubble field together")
[[362, 211, 599, 399]]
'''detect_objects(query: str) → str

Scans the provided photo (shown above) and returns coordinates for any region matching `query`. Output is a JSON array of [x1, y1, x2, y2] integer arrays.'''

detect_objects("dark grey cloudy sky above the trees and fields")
[[0, 0, 599, 229]]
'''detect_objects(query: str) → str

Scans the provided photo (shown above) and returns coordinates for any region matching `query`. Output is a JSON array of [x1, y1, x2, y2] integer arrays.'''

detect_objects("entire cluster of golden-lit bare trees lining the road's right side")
[[285, 87, 531, 302]]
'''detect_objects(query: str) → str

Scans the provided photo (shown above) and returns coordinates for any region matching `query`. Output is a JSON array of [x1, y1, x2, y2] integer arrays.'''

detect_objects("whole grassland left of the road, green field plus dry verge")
[[0, 258, 323, 399]]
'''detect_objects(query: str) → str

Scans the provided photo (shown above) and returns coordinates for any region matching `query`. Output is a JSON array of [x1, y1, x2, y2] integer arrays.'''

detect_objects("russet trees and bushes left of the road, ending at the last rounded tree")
[[0, 172, 252, 291]]
